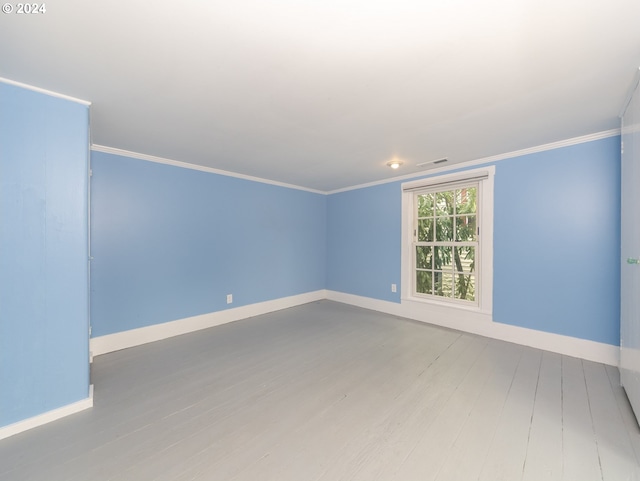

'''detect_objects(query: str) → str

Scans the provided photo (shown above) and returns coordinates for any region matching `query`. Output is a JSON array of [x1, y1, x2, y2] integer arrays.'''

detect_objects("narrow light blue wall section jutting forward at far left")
[[0, 83, 89, 426]]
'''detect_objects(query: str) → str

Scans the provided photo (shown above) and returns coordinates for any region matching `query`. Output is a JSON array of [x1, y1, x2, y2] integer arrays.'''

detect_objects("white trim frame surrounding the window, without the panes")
[[401, 165, 495, 315]]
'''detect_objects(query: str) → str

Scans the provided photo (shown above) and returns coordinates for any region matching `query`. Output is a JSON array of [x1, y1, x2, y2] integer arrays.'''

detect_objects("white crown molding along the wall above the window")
[[325, 128, 620, 195]]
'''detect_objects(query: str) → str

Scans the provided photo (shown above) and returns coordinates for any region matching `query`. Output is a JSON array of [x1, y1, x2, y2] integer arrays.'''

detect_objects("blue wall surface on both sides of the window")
[[327, 137, 620, 345]]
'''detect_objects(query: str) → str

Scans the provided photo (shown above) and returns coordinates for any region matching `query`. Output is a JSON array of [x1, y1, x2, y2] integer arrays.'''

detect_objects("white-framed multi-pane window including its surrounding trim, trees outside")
[[402, 167, 494, 312]]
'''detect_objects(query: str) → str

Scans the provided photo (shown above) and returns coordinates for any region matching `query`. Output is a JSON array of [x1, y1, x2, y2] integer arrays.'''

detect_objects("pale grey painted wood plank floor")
[[0, 301, 640, 481]]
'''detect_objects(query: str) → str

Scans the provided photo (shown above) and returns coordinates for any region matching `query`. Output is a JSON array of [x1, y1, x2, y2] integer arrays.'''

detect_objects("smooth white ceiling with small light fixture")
[[0, 0, 640, 191]]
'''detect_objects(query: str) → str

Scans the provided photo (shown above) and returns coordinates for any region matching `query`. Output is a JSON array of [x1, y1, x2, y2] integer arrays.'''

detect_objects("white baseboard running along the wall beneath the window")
[[327, 291, 620, 366]]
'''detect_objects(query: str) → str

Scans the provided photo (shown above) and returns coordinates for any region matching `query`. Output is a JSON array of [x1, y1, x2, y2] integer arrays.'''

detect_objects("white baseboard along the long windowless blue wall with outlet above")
[[90, 290, 327, 356]]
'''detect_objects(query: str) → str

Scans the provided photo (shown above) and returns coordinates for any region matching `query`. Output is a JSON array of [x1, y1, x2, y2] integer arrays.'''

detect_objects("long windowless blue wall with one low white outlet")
[[91, 152, 326, 336]]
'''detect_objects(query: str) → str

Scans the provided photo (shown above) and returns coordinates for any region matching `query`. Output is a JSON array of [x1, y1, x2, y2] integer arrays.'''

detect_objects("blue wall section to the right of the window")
[[494, 137, 620, 345]]
